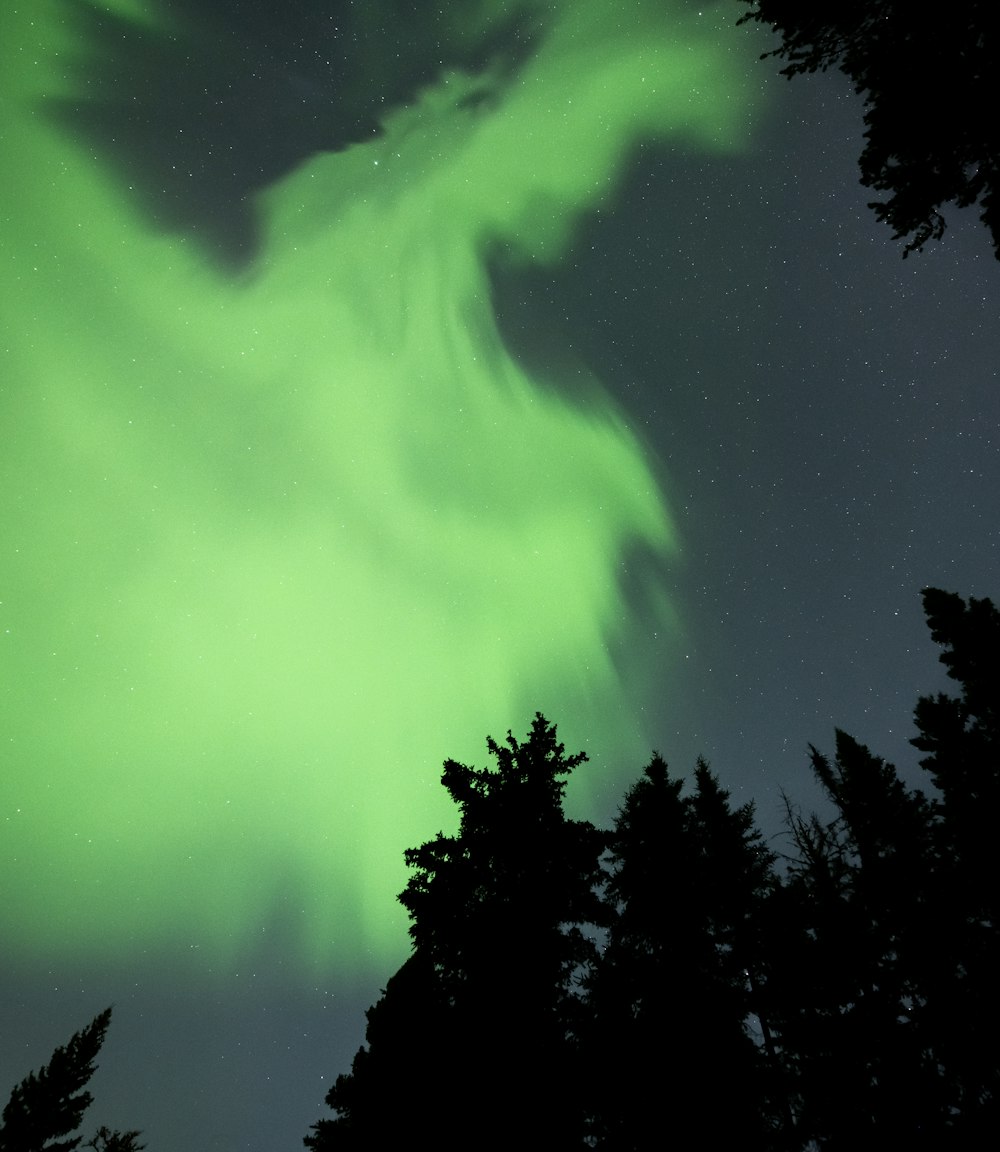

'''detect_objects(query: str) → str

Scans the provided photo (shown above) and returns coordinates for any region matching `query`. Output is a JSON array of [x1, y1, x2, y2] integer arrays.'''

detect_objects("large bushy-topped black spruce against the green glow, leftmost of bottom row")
[[305, 714, 605, 1152]]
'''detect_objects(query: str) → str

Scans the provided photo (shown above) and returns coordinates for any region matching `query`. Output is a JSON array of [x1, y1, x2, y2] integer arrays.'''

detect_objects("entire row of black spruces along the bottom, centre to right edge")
[[305, 589, 1000, 1152]]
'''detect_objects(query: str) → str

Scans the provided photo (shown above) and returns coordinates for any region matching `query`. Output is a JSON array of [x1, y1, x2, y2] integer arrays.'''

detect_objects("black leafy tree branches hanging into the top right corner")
[[740, 0, 1000, 257]]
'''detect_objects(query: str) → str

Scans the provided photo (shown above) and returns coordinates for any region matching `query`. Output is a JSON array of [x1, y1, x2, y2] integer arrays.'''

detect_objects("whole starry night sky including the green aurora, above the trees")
[[0, 0, 1000, 1152]]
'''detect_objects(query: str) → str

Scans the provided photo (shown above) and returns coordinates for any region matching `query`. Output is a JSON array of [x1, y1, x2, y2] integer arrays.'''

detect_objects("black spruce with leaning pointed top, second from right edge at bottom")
[[771, 732, 949, 1152]]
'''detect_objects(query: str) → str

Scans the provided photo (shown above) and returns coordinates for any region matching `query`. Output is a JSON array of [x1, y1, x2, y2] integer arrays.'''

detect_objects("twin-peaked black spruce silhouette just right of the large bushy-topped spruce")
[[589, 756, 780, 1150]]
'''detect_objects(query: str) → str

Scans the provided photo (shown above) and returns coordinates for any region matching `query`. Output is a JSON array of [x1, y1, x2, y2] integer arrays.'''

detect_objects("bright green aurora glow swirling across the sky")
[[0, 0, 748, 969]]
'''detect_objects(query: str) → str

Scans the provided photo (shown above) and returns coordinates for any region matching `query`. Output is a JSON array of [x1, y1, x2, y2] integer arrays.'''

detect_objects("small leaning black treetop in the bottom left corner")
[[0, 1008, 111, 1152]]
